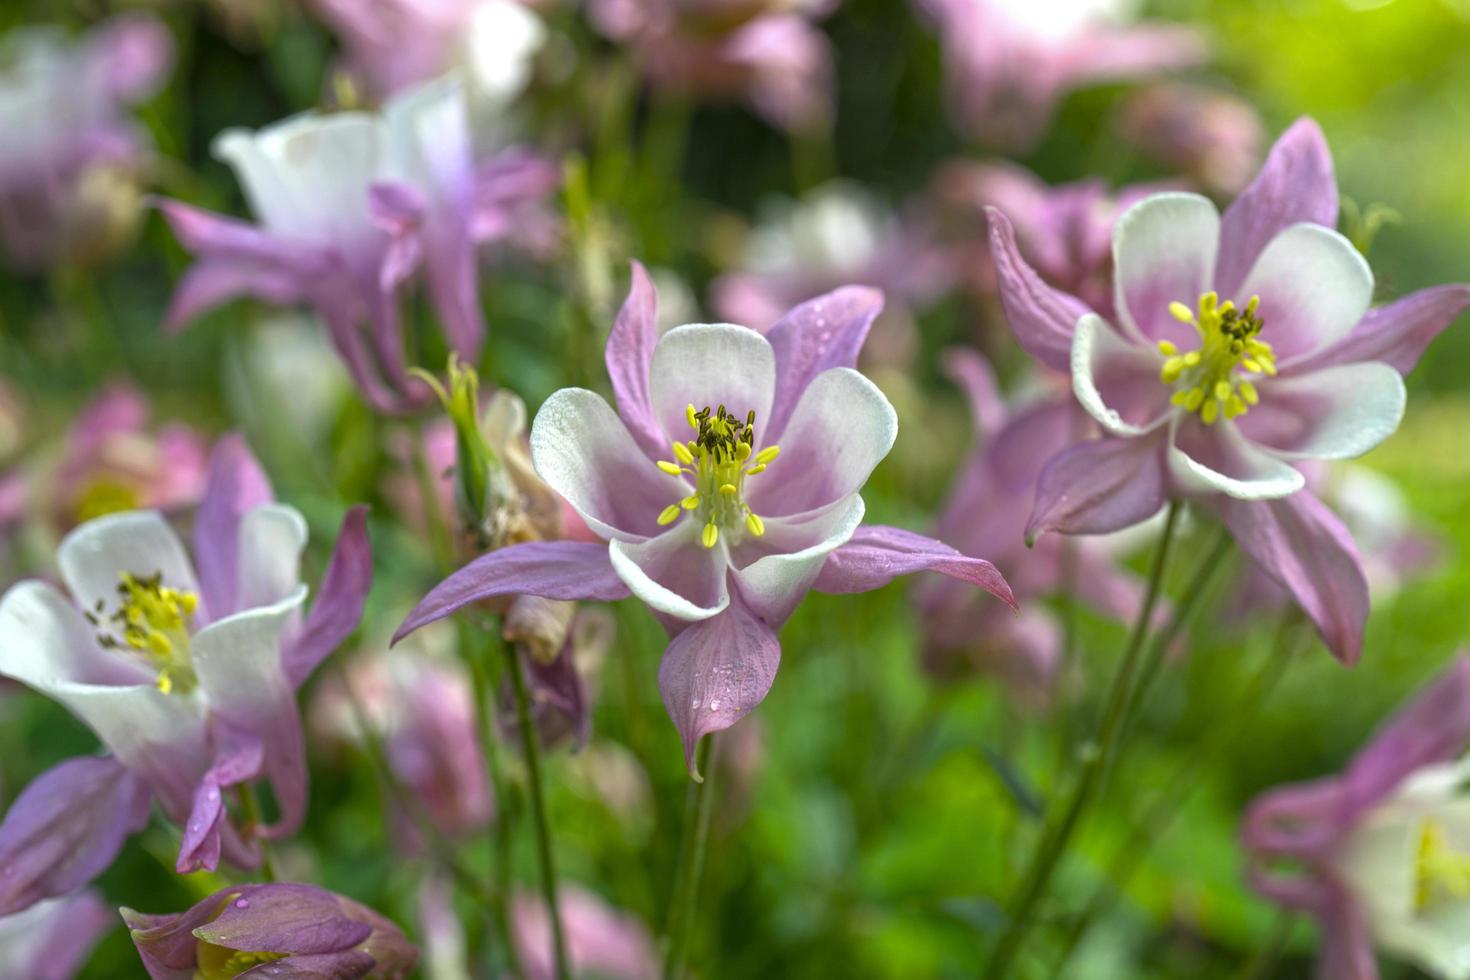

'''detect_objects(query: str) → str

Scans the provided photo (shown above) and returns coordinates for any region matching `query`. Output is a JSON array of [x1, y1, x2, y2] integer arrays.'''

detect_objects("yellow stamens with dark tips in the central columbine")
[[659, 406, 781, 548]]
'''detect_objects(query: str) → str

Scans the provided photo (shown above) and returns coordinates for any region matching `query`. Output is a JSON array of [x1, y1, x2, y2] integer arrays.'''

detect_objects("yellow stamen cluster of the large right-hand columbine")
[[1158, 292, 1276, 425]]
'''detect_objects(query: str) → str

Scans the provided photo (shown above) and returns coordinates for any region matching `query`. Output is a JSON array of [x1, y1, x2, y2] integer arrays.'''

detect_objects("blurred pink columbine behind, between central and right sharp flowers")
[[914, 350, 1142, 705]]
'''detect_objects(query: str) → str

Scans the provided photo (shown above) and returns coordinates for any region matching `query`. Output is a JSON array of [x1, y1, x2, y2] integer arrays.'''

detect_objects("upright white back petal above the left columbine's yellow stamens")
[[56, 510, 198, 613]]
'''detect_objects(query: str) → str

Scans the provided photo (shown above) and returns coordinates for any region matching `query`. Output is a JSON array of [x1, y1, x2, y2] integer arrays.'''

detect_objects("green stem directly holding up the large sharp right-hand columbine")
[[980, 501, 1180, 980]]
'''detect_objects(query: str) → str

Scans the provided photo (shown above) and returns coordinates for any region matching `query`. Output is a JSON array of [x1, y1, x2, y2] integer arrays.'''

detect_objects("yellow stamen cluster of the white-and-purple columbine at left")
[[85, 572, 198, 693]]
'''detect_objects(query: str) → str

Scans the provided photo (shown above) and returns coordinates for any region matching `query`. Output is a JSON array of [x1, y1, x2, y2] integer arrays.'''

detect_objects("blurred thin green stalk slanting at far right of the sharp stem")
[[1053, 610, 1301, 977]]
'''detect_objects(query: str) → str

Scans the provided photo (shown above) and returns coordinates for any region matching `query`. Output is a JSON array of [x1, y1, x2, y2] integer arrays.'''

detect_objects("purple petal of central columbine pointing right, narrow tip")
[[813, 525, 1017, 608]]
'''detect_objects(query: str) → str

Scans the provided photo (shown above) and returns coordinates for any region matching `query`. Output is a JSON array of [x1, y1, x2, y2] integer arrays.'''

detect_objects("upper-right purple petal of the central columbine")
[[757, 287, 883, 445]]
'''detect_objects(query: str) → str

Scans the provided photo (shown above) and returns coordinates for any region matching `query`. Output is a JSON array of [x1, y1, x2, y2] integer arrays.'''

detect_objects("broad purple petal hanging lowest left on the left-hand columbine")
[[0, 757, 150, 915]]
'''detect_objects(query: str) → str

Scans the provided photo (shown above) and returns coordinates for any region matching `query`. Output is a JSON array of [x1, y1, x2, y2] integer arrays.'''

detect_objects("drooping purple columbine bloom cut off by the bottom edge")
[[122, 883, 419, 980]]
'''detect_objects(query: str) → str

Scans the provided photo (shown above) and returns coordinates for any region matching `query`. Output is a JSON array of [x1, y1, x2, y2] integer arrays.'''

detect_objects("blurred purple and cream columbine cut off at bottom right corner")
[[1242, 655, 1470, 980]]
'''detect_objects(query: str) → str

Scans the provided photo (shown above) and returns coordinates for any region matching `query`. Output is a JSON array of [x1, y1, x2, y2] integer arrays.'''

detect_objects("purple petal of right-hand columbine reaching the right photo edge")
[[1282, 285, 1470, 375]]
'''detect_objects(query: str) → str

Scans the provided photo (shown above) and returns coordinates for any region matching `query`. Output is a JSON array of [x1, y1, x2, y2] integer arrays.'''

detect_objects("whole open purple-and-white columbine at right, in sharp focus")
[[992, 119, 1470, 663]]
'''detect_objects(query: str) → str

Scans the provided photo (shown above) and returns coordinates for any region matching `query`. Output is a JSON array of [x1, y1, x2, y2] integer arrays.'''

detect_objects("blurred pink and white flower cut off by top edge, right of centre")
[[917, 0, 1205, 148]]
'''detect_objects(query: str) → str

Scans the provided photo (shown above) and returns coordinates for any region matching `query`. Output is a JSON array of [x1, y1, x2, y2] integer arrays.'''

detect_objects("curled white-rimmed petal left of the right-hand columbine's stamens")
[[1072, 313, 1170, 436]]
